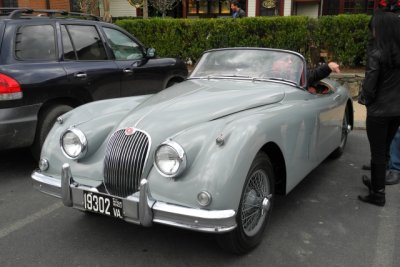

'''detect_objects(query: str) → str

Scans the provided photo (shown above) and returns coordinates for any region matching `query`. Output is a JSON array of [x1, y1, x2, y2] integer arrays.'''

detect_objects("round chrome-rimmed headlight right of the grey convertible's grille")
[[154, 140, 186, 177]]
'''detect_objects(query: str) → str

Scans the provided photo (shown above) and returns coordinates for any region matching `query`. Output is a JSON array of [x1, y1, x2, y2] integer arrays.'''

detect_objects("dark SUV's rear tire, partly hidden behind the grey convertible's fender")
[[31, 105, 73, 161]]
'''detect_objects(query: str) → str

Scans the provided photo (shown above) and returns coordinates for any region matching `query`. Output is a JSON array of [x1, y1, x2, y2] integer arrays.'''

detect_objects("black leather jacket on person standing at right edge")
[[358, 49, 400, 117]]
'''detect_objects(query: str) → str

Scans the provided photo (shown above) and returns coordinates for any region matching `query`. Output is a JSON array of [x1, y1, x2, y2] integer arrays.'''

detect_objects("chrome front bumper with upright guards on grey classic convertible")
[[32, 164, 236, 233]]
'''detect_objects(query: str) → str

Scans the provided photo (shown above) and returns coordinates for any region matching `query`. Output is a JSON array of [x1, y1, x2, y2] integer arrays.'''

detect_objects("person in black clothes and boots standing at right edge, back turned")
[[358, 0, 400, 206]]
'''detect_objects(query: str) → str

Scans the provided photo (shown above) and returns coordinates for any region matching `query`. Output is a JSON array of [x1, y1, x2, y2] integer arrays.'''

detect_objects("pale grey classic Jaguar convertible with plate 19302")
[[32, 48, 353, 253]]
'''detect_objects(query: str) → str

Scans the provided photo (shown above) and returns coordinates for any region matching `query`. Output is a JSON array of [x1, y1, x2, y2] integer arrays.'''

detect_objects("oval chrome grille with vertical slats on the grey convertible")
[[104, 129, 150, 197]]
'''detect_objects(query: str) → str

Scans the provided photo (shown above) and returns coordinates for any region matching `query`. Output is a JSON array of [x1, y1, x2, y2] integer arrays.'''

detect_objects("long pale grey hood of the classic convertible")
[[117, 79, 284, 135]]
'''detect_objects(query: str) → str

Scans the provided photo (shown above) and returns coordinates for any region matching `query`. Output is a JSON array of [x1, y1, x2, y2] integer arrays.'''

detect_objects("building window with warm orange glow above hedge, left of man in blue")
[[188, 0, 230, 17]]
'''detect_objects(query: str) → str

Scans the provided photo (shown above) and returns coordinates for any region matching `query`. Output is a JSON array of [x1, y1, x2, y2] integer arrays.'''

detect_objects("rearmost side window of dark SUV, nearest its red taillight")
[[15, 25, 56, 60]]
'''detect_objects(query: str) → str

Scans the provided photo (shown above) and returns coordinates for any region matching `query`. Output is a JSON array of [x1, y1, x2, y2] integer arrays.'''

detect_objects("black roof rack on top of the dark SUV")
[[0, 7, 101, 21]]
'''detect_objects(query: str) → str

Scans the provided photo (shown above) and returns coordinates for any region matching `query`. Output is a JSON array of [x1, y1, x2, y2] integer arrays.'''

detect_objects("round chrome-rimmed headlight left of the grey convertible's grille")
[[60, 128, 87, 159]]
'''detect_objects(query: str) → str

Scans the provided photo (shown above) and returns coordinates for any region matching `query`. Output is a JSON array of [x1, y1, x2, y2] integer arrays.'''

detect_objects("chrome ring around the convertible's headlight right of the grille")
[[153, 140, 187, 178]]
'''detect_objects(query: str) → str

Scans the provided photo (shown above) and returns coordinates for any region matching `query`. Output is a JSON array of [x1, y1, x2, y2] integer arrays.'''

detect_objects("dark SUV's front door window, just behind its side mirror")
[[103, 28, 144, 60]]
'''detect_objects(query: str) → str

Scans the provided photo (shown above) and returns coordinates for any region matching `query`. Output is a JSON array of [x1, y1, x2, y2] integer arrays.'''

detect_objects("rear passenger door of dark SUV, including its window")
[[60, 24, 121, 100]]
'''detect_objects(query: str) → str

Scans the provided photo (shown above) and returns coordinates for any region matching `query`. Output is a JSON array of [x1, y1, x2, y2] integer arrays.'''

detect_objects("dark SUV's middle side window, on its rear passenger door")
[[62, 25, 107, 60]]
